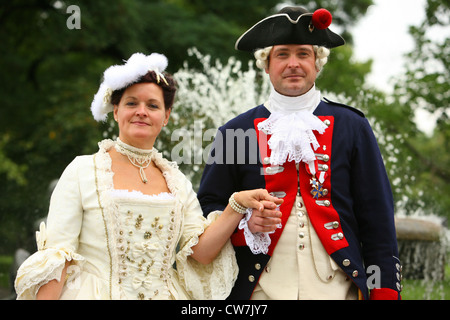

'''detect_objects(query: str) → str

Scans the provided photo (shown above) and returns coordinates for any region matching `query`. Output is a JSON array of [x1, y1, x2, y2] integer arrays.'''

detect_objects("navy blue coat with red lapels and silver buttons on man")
[[198, 100, 401, 299]]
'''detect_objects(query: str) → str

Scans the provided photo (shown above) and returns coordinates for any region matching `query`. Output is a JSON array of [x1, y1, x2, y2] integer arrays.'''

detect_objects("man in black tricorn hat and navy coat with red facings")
[[198, 7, 401, 299]]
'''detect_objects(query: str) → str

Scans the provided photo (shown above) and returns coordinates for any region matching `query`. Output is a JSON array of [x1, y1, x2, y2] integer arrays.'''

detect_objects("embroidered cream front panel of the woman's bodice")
[[110, 193, 180, 299]]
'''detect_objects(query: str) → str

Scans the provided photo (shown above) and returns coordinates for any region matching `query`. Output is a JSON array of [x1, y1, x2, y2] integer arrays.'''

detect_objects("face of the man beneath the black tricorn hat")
[[266, 44, 317, 97]]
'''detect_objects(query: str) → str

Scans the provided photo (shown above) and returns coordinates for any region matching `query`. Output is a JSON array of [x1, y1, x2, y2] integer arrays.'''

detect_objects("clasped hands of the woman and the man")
[[234, 189, 283, 233]]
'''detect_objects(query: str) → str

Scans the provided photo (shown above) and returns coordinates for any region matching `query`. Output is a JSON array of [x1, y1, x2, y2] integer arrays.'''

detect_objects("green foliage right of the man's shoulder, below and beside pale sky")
[[347, 0, 450, 218]]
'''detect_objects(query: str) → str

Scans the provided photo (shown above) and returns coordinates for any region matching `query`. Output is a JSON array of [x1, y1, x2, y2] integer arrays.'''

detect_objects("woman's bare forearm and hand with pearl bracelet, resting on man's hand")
[[191, 189, 283, 264]]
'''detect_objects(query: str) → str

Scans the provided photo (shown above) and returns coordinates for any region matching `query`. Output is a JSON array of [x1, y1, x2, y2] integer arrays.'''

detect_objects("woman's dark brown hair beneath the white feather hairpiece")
[[111, 71, 177, 110]]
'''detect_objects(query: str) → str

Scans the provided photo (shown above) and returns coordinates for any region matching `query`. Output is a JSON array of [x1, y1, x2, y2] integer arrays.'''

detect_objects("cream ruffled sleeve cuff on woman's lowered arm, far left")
[[14, 223, 85, 300]]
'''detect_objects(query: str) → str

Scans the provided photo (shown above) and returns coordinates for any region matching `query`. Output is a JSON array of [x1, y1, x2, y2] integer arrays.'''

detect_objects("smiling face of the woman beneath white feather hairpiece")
[[114, 83, 170, 149]]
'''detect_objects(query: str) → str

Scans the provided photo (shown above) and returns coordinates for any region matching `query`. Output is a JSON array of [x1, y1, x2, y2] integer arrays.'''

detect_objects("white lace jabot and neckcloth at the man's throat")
[[258, 86, 327, 167]]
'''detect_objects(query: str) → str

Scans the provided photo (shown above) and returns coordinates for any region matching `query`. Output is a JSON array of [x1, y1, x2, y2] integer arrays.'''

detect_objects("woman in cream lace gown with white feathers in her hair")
[[16, 53, 279, 299]]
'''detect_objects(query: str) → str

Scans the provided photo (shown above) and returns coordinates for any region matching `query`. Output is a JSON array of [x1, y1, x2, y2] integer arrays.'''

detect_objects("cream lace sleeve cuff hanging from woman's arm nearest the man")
[[176, 211, 238, 300]]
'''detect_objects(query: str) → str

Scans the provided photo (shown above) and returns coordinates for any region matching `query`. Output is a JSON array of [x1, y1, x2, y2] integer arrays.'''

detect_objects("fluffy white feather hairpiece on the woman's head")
[[91, 53, 168, 121]]
